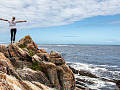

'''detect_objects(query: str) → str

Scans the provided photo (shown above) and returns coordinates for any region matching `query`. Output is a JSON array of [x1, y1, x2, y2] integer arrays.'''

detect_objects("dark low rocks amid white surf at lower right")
[[67, 63, 120, 90]]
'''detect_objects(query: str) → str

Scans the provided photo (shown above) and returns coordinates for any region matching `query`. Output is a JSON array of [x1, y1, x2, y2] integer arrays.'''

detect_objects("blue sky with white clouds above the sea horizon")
[[0, 0, 120, 45]]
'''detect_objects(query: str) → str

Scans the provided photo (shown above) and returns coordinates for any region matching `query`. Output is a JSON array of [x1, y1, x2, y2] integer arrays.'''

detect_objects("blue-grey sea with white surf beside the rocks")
[[38, 45, 120, 90]]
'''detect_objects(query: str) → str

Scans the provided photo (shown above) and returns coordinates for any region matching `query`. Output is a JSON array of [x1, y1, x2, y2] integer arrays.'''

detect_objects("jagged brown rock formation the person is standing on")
[[0, 35, 77, 90]]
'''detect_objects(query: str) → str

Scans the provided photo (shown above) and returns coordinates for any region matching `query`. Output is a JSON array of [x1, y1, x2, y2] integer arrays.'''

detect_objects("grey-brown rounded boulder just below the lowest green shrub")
[[17, 68, 50, 86]]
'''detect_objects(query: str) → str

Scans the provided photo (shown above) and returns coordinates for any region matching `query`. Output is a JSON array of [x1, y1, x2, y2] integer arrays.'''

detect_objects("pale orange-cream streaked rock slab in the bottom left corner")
[[0, 73, 55, 90]]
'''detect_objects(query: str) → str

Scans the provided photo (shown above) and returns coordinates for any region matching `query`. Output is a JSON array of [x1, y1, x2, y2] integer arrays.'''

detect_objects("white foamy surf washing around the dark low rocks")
[[67, 62, 120, 90]]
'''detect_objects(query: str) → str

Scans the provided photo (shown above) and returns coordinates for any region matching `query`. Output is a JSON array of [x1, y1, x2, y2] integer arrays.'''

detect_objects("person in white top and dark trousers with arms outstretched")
[[0, 17, 27, 43]]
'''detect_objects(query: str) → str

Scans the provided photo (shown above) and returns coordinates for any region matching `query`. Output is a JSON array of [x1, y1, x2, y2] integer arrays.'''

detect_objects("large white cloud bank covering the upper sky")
[[0, 0, 120, 33]]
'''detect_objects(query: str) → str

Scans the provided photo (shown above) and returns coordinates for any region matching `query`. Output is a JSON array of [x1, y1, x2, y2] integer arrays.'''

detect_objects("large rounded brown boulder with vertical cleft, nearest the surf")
[[40, 61, 75, 90]]
